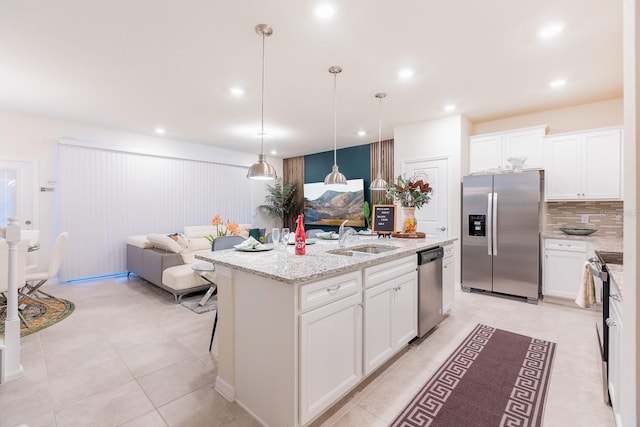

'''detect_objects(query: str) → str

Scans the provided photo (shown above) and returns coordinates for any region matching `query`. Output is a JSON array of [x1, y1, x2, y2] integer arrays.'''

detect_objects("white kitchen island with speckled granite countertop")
[[197, 236, 455, 426]]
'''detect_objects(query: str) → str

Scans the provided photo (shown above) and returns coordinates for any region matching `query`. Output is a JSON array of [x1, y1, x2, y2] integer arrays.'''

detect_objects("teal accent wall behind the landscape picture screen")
[[304, 144, 371, 231]]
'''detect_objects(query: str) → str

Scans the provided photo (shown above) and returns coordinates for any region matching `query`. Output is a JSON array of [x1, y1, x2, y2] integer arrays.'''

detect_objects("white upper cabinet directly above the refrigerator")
[[469, 125, 548, 173]]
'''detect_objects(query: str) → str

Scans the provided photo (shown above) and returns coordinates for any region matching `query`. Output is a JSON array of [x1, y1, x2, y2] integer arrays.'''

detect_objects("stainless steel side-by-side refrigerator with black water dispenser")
[[462, 171, 542, 303]]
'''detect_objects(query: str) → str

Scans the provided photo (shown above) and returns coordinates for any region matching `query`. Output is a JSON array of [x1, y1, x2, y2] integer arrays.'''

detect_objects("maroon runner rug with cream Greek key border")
[[391, 325, 556, 427]]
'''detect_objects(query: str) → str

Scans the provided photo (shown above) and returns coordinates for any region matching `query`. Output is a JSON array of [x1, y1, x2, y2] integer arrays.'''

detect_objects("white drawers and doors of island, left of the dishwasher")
[[298, 255, 418, 425]]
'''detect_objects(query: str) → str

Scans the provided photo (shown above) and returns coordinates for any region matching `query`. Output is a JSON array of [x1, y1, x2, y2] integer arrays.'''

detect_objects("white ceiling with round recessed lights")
[[0, 0, 622, 157]]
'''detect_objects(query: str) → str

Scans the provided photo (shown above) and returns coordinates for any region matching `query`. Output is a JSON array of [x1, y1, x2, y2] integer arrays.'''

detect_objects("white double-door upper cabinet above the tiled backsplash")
[[545, 128, 622, 200]]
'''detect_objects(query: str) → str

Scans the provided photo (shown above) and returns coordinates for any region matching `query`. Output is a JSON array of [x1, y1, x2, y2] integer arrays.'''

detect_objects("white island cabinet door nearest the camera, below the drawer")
[[298, 292, 362, 424]]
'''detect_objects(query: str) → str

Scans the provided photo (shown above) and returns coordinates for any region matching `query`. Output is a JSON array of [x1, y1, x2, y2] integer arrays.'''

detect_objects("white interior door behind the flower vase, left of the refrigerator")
[[402, 158, 449, 238]]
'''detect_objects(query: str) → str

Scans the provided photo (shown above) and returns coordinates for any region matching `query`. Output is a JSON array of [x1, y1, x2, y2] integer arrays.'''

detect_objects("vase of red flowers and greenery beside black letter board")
[[386, 173, 433, 233]]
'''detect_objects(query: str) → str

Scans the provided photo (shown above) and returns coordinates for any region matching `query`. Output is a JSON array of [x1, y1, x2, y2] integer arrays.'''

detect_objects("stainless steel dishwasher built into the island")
[[418, 247, 444, 337]]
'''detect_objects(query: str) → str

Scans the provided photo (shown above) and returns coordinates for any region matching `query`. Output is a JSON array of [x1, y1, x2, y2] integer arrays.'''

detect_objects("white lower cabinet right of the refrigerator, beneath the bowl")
[[542, 239, 589, 298]]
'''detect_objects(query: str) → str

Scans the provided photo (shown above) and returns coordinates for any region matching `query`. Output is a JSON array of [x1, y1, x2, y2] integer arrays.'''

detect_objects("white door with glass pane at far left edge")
[[0, 159, 36, 229]]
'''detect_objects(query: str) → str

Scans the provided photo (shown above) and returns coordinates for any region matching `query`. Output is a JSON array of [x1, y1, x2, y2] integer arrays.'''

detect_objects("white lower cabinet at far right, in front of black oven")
[[607, 285, 623, 427]]
